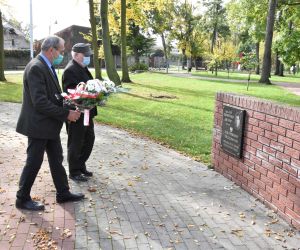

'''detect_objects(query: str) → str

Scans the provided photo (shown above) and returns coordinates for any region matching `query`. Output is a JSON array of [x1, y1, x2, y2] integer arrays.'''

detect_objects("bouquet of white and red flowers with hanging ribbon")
[[61, 79, 116, 126]]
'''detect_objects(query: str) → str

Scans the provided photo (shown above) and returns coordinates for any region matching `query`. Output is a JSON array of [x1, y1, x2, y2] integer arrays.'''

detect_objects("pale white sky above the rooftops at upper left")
[[0, 0, 90, 40]]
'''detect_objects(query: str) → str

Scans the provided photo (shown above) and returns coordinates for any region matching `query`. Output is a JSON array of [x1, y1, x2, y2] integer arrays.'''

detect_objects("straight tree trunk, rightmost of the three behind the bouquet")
[[121, 0, 131, 82]]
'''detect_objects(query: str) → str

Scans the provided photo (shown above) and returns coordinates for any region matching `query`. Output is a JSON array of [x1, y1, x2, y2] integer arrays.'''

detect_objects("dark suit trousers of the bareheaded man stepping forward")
[[17, 137, 70, 201]]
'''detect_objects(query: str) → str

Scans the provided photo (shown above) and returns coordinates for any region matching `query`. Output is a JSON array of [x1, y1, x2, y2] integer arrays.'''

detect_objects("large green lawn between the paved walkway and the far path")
[[0, 73, 300, 164]]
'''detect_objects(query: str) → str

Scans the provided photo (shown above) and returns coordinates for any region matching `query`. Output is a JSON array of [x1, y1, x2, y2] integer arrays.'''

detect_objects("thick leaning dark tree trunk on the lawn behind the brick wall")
[[259, 0, 277, 84]]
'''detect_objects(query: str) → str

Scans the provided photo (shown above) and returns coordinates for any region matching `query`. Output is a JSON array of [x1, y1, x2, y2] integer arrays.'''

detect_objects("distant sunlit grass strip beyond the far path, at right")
[[192, 70, 300, 84]]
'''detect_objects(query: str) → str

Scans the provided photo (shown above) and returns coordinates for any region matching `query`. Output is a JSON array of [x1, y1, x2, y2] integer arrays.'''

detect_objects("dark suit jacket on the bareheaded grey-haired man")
[[16, 55, 69, 139]]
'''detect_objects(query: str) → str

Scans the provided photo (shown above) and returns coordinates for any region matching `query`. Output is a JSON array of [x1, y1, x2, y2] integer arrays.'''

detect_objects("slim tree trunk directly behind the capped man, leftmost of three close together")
[[89, 0, 103, 80]]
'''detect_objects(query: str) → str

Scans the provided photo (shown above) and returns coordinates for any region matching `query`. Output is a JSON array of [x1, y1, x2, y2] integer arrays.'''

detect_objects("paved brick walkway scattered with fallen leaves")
[[0, 103, 300, 250]]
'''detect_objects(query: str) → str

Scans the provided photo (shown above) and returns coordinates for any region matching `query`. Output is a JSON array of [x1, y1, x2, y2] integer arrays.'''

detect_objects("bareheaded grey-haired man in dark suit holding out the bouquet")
[[16, 36, 84, 210]]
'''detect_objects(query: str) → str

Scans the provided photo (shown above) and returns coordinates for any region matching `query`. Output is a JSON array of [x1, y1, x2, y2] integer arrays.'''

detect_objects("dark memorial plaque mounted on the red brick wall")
[[221, 105, 246, 158]]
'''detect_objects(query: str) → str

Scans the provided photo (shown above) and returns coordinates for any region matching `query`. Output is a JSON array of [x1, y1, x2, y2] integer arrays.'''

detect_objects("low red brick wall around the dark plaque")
[[212, 93, 300, 229]]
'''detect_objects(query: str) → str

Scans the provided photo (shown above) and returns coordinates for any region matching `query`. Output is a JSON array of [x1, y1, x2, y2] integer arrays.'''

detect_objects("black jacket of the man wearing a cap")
[[62, 60, 97, 117]]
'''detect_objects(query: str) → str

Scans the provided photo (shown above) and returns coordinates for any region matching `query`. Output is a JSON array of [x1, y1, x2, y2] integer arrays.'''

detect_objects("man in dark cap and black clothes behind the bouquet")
[[62, 43, 97, 181]]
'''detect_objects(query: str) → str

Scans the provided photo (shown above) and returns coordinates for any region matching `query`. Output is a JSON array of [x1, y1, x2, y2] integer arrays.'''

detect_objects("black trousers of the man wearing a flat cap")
[[66, 114, 95, 176]]
